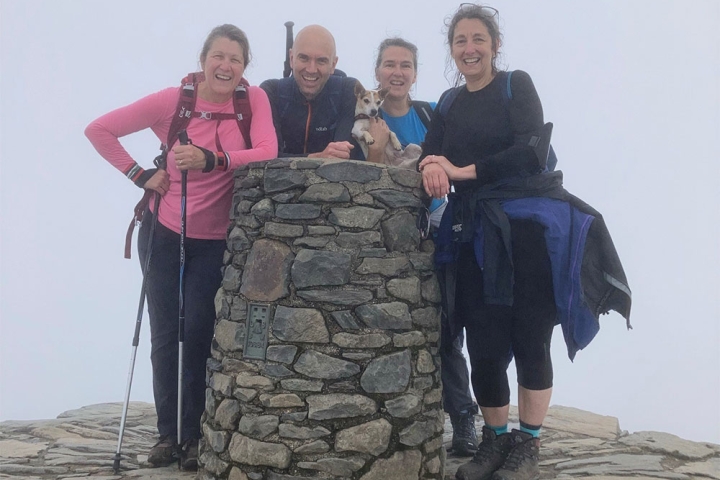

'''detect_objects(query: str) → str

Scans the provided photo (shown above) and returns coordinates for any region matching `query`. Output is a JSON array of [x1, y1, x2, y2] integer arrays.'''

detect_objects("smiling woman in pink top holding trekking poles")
[[85, 25, 278, 468]]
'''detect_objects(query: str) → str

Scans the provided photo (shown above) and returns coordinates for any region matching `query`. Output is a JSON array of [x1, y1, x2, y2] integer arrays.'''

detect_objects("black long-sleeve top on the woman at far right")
[[423, 70, 544, 193]]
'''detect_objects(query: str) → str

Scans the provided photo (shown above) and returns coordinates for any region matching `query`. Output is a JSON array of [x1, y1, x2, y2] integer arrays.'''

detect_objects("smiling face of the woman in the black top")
[[451, 18, 497, 89]]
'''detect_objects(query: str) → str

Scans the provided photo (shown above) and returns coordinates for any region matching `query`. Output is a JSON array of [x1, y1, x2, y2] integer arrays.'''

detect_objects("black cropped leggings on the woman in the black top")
[[455, 220, 556, 407]]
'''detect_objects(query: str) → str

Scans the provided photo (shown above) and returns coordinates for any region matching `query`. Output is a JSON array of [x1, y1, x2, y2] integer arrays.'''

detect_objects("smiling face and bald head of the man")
[[290, 25, 338, 100]]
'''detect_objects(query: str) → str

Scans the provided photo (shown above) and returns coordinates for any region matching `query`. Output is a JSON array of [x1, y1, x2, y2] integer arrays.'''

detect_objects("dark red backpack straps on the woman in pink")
[[125, 72, 252, 258]]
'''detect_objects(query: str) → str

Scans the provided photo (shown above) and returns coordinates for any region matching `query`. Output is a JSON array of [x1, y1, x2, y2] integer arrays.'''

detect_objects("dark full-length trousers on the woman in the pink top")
[[138, 211, 225, 439]]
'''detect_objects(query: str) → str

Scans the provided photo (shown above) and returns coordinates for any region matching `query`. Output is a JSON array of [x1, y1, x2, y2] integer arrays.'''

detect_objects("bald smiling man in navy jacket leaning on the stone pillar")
[[260, 25, 386, 160]]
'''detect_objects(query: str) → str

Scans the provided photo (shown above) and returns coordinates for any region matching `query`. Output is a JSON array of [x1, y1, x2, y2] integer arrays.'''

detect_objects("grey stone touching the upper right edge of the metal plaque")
[[272, 305, 330, 344]]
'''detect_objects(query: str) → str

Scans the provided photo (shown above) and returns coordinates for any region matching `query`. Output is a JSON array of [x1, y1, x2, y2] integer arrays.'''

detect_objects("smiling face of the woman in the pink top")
[[199, 37, 245, 103]]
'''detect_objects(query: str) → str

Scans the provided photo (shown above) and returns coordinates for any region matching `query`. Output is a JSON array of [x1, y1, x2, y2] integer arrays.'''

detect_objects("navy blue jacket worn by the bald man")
[[260, 75, 365, 160]]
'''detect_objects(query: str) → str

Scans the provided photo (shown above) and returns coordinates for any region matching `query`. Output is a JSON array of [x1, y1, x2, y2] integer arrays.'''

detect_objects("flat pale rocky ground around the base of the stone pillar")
[[0, 402, 720, 480]]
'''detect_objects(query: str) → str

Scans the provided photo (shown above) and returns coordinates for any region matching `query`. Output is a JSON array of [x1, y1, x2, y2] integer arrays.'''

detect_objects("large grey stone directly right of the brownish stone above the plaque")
[[291, 249, 351, 288]]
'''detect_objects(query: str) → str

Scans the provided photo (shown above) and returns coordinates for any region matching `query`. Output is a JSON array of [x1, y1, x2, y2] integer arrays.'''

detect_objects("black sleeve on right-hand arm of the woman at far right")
[[475, 70, 544, 183]]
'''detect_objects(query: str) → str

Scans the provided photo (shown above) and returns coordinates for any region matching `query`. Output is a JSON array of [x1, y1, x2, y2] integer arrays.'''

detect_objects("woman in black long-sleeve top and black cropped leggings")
[[420, 4, 556, 480]]
